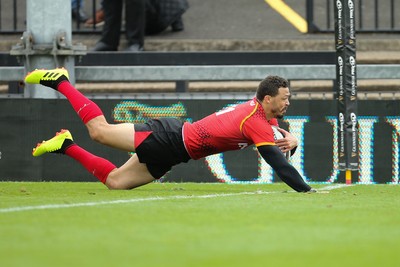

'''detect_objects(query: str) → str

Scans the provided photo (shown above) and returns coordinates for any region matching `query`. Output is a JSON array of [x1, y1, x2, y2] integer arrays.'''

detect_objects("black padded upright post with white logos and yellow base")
[[335, 0, 358, 184]]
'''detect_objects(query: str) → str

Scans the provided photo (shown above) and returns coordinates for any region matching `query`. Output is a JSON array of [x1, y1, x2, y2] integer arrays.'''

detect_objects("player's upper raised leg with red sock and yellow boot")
[[25, 68, 134, 151]]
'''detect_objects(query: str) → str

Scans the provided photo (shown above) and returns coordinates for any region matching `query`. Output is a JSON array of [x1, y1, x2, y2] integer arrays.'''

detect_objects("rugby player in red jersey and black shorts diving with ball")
[[25, 68, 315, 192]]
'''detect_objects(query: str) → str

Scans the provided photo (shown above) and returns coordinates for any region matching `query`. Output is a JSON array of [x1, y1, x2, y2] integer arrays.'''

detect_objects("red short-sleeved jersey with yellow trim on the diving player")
[[183, 98, 278, 159]]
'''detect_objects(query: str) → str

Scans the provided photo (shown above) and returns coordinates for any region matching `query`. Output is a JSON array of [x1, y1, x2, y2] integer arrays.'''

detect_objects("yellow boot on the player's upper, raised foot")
[[25, 68, 69, 90]]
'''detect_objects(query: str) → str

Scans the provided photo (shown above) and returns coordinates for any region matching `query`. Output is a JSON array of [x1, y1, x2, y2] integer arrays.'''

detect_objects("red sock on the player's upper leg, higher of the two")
[[57, 81, 103, 124]]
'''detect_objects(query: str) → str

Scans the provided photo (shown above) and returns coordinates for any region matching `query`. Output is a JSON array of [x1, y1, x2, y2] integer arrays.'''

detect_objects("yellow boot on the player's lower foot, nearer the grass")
[[32, 129, 74, 157]]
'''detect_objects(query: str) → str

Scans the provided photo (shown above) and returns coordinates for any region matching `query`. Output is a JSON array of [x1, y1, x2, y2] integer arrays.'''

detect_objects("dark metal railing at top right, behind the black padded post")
[[306, 0, 400, 33]]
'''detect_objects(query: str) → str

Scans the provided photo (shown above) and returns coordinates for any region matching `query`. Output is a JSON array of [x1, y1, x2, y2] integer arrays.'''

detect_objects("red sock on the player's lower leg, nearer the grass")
[[65, 144, 116, 184]]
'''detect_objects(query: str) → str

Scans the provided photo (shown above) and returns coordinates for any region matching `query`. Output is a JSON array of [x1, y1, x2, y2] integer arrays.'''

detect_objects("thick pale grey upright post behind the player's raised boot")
[[24, 0, 75, 98]]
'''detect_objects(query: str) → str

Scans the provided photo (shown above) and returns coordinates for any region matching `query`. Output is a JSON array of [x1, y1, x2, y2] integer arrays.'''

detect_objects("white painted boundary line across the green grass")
[[0, 184, 348, 213]]
